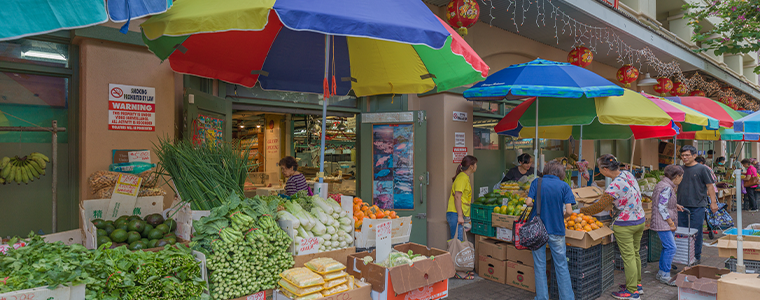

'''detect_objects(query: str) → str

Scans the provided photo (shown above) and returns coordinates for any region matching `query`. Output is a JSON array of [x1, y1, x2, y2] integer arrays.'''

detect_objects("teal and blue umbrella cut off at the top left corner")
[[0, 0, 173, 41]]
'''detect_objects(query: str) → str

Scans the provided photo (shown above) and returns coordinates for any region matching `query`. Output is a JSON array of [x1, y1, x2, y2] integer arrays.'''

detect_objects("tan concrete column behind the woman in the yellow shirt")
[[418, 93, 472, 249]]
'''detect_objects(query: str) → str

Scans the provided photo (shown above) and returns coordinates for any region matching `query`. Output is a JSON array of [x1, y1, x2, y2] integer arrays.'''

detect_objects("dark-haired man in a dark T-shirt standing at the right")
[[677, 145, 718, 264]]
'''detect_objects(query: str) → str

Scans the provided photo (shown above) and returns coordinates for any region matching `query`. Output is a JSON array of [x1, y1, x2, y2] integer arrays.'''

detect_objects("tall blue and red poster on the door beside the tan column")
[[372, 124, 414, 209]]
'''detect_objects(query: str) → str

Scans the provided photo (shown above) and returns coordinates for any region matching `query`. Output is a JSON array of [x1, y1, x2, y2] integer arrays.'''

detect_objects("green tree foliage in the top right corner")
[[683, 0, 760, 73]]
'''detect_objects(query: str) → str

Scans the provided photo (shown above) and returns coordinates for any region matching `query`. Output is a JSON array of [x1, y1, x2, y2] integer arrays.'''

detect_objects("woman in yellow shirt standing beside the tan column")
[[446, 155, 478, 240]]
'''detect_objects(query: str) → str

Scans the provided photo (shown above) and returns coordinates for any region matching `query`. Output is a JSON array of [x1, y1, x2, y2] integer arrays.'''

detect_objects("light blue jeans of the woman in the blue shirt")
[[533, 234, 575, 300]]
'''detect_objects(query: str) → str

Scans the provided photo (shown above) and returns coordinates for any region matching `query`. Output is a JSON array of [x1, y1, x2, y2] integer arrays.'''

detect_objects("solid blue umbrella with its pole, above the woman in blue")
[[464, 58, 624, 175]]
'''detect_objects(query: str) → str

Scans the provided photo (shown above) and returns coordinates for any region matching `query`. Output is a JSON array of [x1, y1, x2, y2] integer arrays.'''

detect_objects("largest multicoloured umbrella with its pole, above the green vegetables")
[[141, 0, 488, 182]]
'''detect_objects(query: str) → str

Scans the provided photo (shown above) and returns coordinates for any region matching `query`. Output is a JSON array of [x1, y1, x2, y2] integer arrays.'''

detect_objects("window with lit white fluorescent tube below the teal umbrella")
[[0, 39, 69, 68]]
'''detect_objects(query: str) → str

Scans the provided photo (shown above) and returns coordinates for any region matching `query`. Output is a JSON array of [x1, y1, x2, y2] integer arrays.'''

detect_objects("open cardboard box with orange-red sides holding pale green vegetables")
[[346, 243, 456, 299]]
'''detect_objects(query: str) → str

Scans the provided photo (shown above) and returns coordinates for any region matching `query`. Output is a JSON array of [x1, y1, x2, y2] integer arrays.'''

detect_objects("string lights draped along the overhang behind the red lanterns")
[[502, 0, 760, 110]]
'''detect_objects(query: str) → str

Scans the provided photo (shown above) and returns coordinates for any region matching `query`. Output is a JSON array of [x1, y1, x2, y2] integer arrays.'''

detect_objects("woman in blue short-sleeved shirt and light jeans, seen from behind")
[[526, 160, 575, 300]]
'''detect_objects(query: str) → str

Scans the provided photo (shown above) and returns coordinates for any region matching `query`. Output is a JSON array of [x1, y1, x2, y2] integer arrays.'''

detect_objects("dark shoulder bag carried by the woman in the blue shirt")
[[512, 178, 549, 251]]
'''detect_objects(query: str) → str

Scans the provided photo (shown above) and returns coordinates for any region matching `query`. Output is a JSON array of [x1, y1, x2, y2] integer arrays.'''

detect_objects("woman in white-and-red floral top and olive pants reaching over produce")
[[581, 154, 646, 300]]
